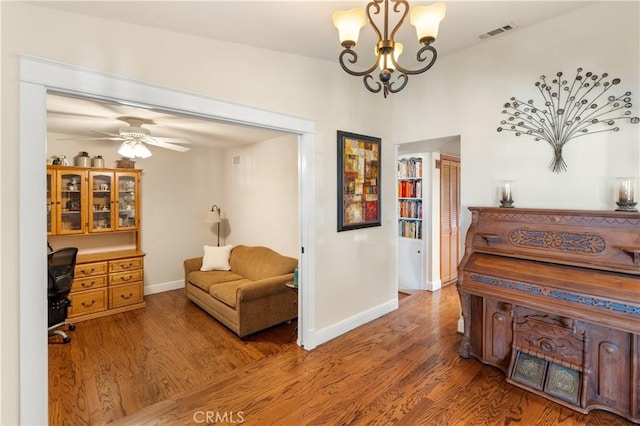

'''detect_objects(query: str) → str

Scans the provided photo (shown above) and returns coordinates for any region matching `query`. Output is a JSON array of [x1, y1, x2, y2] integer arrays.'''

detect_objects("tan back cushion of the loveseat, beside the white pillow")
[[229, 245, 298, 281]]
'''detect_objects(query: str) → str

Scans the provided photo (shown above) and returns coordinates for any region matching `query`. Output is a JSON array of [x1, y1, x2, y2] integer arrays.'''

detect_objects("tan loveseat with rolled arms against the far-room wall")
[[184, 245, 298, 337]]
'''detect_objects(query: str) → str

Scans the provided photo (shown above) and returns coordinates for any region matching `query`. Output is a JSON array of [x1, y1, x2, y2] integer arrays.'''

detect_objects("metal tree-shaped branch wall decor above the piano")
[[498, 68, 640, 173]]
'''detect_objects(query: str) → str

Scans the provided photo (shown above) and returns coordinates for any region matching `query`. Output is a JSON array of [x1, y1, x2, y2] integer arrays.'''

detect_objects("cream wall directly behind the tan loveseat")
[[219, 135, 300, 258]]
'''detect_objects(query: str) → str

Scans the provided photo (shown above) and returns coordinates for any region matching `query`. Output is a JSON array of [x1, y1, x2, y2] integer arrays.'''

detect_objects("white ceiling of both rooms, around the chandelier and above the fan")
[[37, 0, 594, 148]]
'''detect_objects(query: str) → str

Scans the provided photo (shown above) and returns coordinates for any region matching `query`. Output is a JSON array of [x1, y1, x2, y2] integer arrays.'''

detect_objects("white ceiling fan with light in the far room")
[[58, 116, 191, 158]]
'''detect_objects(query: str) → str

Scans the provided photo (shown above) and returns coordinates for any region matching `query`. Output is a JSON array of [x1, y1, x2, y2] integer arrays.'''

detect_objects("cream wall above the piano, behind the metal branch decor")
[[393, 2, 640, 238]]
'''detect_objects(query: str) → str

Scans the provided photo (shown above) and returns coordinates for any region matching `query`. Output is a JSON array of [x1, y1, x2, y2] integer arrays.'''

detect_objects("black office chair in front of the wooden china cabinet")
[[47, 247, 78, 343]]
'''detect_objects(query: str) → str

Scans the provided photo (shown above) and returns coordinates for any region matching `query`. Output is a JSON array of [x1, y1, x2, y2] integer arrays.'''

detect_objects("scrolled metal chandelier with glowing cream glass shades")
[[332, 0, 446, 98]]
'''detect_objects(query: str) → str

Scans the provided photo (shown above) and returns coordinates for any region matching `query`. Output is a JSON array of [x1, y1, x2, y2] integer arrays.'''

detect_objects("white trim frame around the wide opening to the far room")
[[18, 55, 316, 424]]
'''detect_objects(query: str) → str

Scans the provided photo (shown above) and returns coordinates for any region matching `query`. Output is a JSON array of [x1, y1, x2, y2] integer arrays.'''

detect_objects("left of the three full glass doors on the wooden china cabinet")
[[56, 170, 86, 235]]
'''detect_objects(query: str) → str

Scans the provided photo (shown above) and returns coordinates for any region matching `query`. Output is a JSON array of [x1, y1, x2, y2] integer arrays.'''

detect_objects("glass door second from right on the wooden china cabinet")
[[88, 172, 114, 232]]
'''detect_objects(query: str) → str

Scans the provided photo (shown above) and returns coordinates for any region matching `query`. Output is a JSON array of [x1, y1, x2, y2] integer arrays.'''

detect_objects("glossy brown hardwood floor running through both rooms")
[[49, 286, 631, 426]]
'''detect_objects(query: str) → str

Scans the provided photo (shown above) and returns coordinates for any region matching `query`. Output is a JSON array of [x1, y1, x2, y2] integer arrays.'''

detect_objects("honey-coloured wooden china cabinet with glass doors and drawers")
[[47, 166, 145, 322]]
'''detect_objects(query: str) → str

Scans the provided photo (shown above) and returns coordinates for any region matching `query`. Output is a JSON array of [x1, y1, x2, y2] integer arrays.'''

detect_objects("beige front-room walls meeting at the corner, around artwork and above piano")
[[0, 2, 640, 424]]
